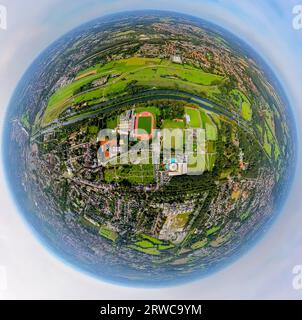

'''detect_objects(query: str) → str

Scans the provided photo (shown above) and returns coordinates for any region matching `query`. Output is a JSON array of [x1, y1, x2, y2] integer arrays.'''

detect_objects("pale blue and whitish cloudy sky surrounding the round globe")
[[0, 1, 302, 298]]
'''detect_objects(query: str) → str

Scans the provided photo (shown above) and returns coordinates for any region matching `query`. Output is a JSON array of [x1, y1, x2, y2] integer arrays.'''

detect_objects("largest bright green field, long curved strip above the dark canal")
[[40, 57, 225, 126]]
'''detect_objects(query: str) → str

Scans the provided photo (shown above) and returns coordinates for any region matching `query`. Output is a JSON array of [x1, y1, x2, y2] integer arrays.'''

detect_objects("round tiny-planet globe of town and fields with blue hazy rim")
[[3, 11, 295, 286]]
